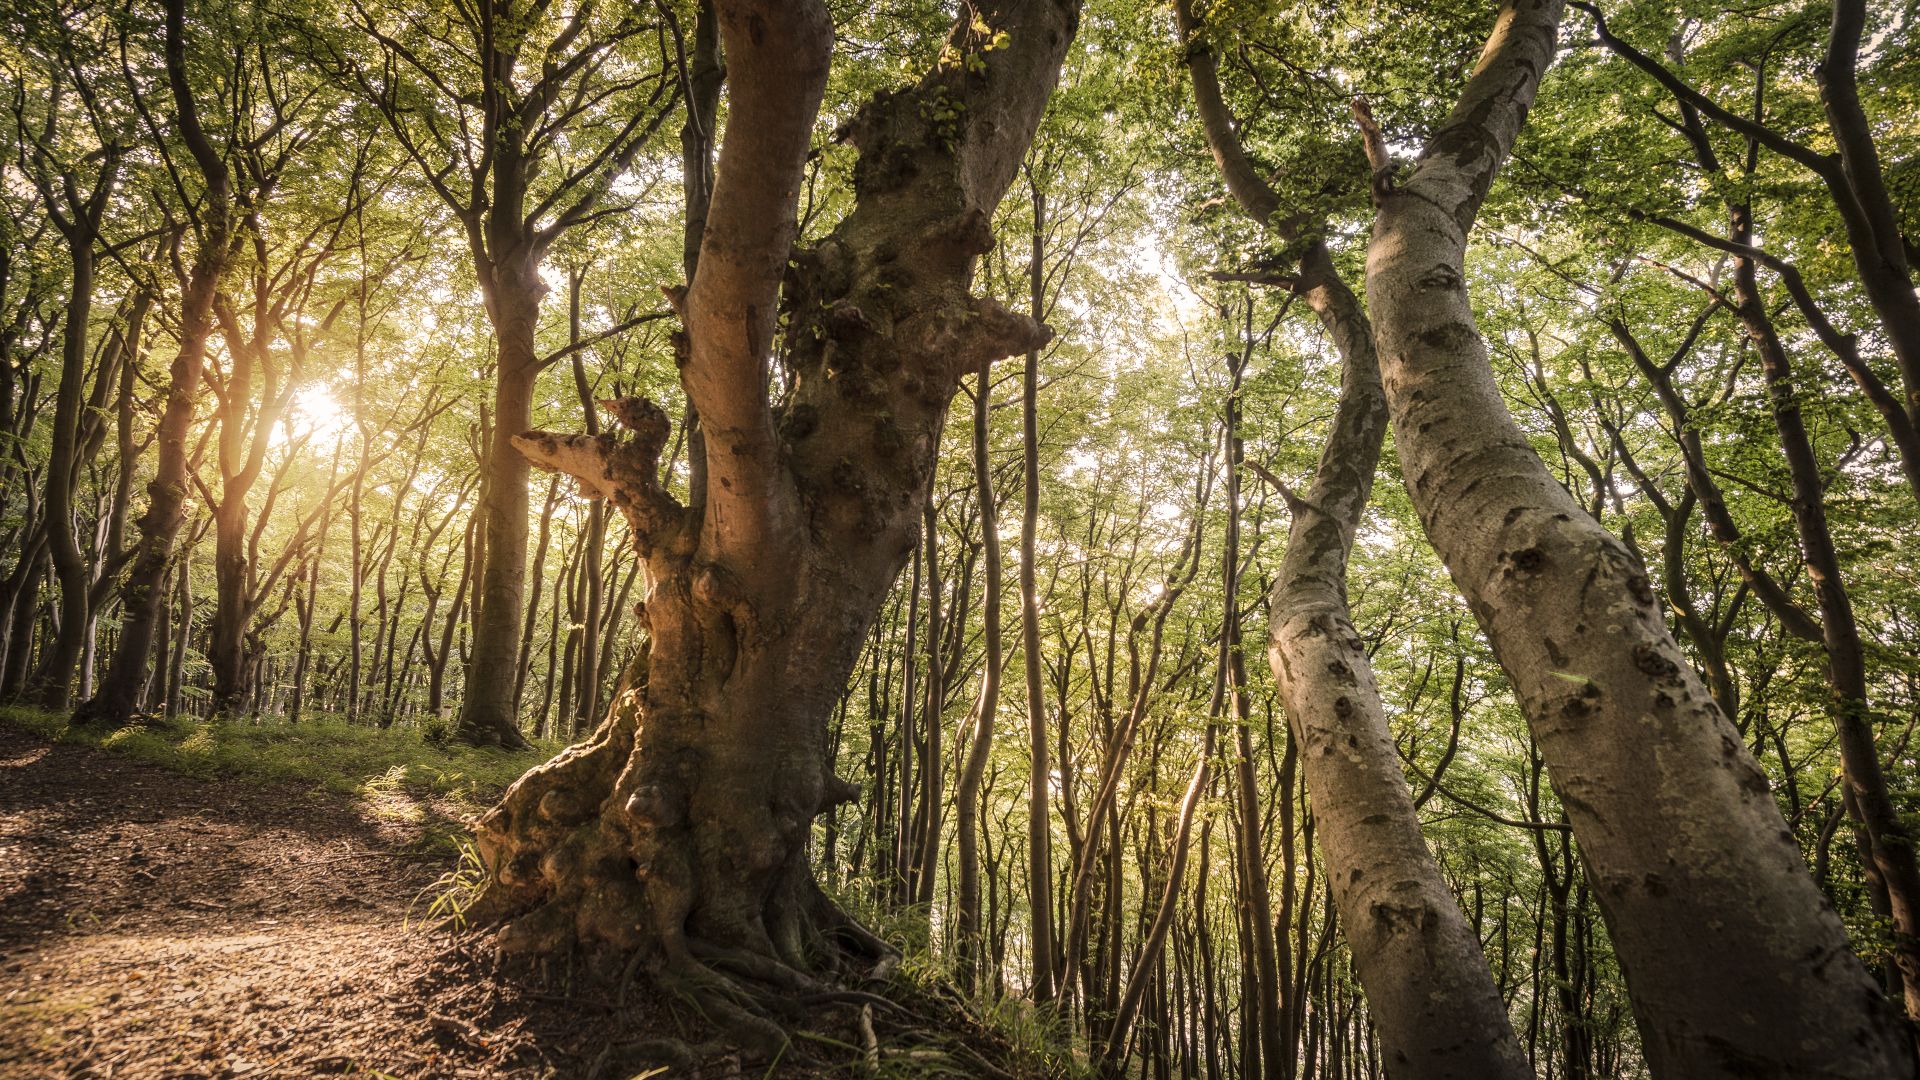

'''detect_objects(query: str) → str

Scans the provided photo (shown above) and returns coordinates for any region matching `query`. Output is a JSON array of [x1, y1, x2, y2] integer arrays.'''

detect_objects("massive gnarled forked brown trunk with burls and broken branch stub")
[[458, 0, 1077, 1053]]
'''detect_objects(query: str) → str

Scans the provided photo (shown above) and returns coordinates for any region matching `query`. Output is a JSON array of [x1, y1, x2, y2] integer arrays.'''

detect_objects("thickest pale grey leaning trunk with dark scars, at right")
[[1367, 0, 1912, 1076]]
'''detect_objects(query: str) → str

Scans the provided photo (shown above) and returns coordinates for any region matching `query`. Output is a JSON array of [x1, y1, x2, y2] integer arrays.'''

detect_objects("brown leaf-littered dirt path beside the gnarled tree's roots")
[[0, 728, 670, 1078]]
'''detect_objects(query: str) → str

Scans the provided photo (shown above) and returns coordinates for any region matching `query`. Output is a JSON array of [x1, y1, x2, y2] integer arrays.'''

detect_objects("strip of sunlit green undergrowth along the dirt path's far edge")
[[0, 707, 563, 845]]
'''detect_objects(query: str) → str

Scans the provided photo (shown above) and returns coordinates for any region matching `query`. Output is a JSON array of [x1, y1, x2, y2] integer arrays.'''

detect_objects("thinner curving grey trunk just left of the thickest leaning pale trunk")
[[1177, 0, 1528, 1078]]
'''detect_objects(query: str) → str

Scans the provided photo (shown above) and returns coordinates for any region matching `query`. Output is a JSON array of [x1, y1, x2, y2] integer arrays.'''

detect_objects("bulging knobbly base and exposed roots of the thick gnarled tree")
[[467, 663, 929, 1068]]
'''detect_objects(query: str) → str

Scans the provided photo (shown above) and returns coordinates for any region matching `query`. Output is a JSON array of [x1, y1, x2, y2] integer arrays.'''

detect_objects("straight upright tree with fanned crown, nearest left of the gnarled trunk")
[[338, 0, 678, 748]]
